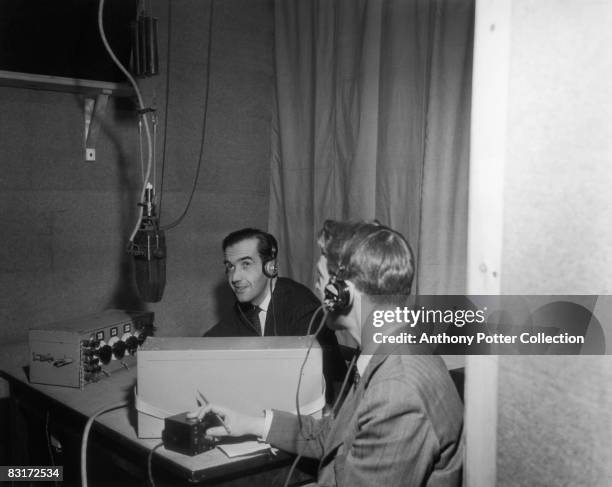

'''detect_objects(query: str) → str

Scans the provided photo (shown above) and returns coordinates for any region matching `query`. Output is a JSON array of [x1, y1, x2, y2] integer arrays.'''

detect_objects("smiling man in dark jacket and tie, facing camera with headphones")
[[205, 228, 321, 337]]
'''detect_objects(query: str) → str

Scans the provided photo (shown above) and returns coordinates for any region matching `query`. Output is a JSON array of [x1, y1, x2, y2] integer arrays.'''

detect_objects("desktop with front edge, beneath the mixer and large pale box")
[[0, 344, 310, 485]]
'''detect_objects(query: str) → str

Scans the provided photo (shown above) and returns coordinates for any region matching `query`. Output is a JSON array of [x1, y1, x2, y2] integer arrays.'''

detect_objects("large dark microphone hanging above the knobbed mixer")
[[127, 183, 166, 303]]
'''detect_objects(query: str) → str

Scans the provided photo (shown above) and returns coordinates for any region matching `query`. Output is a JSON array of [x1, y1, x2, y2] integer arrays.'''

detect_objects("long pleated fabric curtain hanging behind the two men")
[[269, 0, 474, 293]]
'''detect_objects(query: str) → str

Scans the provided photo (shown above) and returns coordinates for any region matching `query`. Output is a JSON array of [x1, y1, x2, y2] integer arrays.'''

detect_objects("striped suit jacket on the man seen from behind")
[[267, 347, 463, 487]]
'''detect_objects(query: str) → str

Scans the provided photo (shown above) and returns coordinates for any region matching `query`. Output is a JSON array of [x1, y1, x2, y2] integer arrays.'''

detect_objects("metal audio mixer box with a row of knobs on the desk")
[[29, 309, 154, 388]]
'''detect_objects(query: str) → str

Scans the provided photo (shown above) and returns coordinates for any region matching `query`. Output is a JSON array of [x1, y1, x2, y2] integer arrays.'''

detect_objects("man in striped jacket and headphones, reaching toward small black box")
[[190, 221, 463, 487]]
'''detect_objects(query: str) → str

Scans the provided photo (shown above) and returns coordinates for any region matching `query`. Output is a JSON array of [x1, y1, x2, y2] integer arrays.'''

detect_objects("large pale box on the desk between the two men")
[[136, 337, 325, 438]]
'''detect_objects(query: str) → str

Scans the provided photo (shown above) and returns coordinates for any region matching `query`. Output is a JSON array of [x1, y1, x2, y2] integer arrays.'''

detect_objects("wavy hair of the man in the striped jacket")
[[318, 220, 414, 297]]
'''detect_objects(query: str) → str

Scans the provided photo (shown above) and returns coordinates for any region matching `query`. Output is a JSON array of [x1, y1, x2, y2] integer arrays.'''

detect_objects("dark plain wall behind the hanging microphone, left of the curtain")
[[0, 0, 273, 343]]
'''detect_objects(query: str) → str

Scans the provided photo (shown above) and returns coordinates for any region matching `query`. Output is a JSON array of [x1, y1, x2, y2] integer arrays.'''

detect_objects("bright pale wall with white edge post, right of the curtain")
[[466, 0, 612, 487]]
